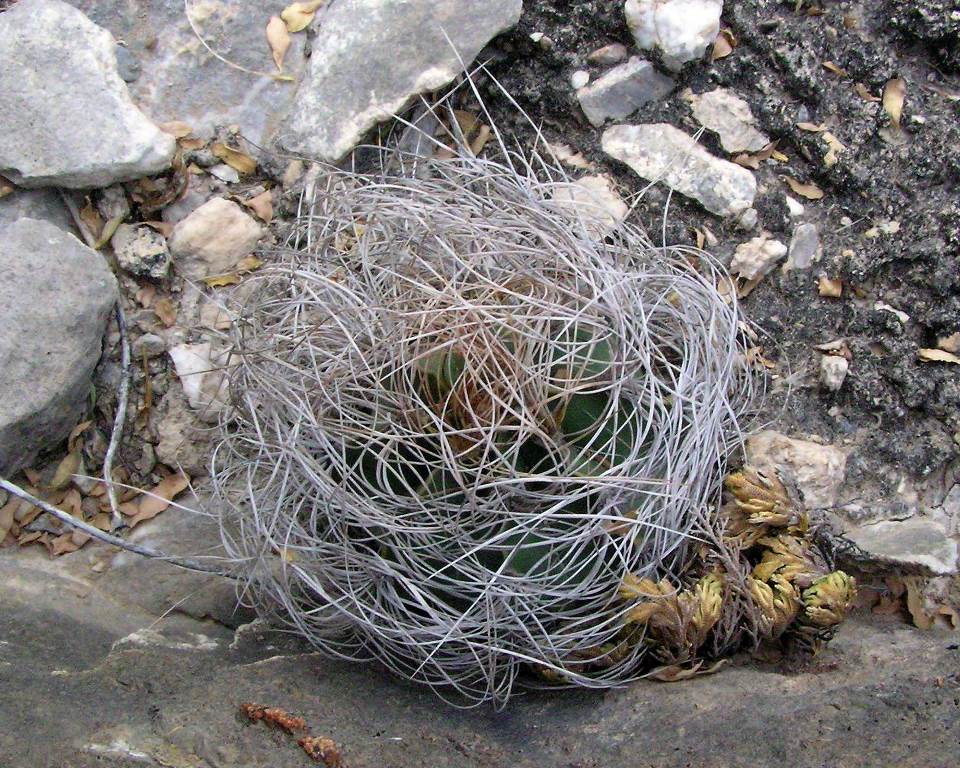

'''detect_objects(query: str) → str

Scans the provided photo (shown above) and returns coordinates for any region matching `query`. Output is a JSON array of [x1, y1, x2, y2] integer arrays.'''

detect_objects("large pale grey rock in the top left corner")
[[0, 0, 175, 188]]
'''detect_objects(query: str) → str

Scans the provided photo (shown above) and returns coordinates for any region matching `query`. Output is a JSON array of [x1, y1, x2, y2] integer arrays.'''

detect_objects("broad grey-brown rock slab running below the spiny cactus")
[[0, 504, 960, 768]]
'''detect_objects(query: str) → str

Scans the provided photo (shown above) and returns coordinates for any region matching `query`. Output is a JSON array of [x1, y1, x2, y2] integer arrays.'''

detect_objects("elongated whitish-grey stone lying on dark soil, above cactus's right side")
[[602, 123, 757, 216]]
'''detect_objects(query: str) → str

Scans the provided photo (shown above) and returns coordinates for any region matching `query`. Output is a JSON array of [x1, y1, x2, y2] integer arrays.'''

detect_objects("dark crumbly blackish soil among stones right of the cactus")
[[483, 0, 960, 516]]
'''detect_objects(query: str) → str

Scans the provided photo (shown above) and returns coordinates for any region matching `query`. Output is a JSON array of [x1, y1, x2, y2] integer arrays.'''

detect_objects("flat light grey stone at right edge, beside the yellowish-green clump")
[[844, 517, 957, 576]]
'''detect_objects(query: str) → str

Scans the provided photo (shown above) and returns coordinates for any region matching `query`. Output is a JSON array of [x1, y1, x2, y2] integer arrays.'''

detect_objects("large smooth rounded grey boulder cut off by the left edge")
[[0, 219, 117, 476]]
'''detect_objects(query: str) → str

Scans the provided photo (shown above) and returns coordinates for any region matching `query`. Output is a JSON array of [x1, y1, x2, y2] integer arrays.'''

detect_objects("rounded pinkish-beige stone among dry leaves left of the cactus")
[[170, 197, 263, 280]]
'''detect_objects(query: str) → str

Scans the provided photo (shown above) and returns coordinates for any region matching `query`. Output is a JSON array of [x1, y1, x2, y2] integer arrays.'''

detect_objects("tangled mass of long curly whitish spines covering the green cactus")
[[213, 103, 755, 703]]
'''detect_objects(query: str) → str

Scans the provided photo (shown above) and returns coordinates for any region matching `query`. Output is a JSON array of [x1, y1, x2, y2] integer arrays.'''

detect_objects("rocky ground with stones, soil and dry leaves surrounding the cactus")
[[0, 0, 960, 766]]
